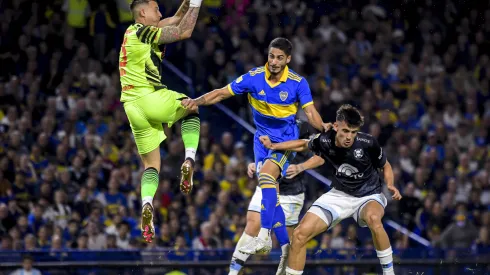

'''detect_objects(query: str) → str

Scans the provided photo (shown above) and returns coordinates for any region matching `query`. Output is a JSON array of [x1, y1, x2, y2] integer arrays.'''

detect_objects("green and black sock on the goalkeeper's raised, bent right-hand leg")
[[181, 114, 201, 162]]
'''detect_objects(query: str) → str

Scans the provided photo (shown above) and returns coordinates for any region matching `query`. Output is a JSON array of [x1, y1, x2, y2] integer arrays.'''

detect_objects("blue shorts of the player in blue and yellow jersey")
[[254, 136, 296, 177]]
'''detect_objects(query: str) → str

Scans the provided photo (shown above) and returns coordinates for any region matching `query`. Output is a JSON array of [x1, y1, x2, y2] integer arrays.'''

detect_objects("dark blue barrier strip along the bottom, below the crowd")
[[0, 248, 490, 275]]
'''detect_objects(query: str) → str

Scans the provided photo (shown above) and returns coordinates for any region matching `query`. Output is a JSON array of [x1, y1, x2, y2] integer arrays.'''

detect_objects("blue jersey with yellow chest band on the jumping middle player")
[[228, 64, 313, 142]]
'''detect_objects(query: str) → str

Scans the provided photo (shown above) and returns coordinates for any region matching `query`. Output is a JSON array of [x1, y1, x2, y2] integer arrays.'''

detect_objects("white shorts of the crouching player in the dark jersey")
[[308, 188, 387, 228]]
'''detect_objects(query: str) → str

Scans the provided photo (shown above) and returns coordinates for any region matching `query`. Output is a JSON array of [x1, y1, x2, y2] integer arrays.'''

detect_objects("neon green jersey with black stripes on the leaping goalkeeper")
[[119, 23, 166, 102]]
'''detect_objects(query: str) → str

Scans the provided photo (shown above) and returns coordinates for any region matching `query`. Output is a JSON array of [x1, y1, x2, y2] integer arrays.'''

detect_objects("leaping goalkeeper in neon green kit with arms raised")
[[119, 0, 202, 242]]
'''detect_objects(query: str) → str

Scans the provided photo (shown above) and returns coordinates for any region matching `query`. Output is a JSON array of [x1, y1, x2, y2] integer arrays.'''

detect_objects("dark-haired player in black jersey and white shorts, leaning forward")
[[260, 105, 401, 275]]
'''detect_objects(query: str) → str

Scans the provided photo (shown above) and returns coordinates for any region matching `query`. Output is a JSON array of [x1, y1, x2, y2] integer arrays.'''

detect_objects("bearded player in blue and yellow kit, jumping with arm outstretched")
[[182, 38, 324, 274]]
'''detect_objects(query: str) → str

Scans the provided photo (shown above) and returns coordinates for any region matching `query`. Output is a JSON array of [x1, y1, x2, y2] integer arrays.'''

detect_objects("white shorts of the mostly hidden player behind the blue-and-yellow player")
[[248, 186, 305, 226]]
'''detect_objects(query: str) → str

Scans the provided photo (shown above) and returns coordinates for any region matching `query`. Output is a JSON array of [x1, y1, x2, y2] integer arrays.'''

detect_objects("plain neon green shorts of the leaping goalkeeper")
[[124, 89, 188, 155]]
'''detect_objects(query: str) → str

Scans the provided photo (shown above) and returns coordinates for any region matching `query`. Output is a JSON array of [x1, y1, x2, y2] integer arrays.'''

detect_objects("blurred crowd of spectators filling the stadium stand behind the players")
[[0, 0, 490, 256]]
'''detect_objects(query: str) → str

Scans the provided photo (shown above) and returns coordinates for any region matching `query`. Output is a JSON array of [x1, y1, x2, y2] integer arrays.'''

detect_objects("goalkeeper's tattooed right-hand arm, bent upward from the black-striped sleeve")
[[159, 7, 200, 44]]
